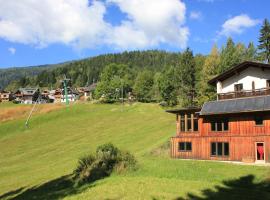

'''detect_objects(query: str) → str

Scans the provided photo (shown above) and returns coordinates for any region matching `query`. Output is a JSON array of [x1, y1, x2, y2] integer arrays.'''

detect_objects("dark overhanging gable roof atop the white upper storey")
[[208, 61, 270, 85]]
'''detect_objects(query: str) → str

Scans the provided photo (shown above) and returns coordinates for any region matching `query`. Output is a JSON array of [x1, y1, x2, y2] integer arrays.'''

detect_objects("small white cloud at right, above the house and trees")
[[219, 14, 260, 36]]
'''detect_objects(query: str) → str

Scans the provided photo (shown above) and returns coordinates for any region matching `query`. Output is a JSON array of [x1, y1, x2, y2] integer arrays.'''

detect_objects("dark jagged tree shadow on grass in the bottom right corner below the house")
[[175, 175, 270, 200]]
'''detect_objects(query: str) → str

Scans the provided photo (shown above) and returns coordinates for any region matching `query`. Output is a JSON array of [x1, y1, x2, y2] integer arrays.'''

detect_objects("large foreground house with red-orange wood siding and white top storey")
[[167, 62, 270, 163]]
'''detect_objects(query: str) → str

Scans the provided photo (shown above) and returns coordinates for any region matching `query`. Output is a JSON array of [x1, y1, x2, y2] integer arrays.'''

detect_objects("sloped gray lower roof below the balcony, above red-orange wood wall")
[[200, 96, 270, 115]]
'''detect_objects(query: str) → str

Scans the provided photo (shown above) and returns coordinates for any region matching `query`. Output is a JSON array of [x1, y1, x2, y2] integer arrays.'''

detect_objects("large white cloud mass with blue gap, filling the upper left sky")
[[0, 0, 189, 49]]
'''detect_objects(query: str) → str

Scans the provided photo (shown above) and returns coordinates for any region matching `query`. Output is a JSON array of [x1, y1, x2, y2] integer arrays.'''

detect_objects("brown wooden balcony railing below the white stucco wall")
[[217, 88, 270, 100]]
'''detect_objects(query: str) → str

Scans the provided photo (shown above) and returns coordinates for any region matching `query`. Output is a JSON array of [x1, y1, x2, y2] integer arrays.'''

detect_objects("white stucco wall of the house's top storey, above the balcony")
[[217, 67, 270, 93]]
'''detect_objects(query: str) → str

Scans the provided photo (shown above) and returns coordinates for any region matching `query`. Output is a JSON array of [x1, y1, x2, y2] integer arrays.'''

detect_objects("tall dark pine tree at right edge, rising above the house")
[[258, 19, 270, 63]]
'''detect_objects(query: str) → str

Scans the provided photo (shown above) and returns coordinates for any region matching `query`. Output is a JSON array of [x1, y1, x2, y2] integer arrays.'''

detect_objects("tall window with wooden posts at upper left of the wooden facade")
[[180, 114, 199, 132]]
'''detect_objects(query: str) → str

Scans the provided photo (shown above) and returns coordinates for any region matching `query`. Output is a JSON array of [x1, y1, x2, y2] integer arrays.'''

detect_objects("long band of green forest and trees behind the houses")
[[3, 19, 270, 107]]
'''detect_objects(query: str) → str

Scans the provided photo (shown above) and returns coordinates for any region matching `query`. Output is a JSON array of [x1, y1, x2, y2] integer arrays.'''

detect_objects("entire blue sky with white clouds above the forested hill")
[[0, 0, 270, 68]]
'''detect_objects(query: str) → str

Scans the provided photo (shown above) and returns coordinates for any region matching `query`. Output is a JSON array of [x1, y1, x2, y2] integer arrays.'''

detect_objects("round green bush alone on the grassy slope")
[[73, 143, 137, 185]]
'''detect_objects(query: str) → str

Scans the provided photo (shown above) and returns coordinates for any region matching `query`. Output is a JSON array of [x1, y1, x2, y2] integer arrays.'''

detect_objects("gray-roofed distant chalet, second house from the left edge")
[[14, 88, 40, 104]]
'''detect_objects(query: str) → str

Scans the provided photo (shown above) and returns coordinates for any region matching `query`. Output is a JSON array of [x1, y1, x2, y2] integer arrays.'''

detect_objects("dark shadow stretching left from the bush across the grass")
[[0, 175, 94, 200]]
